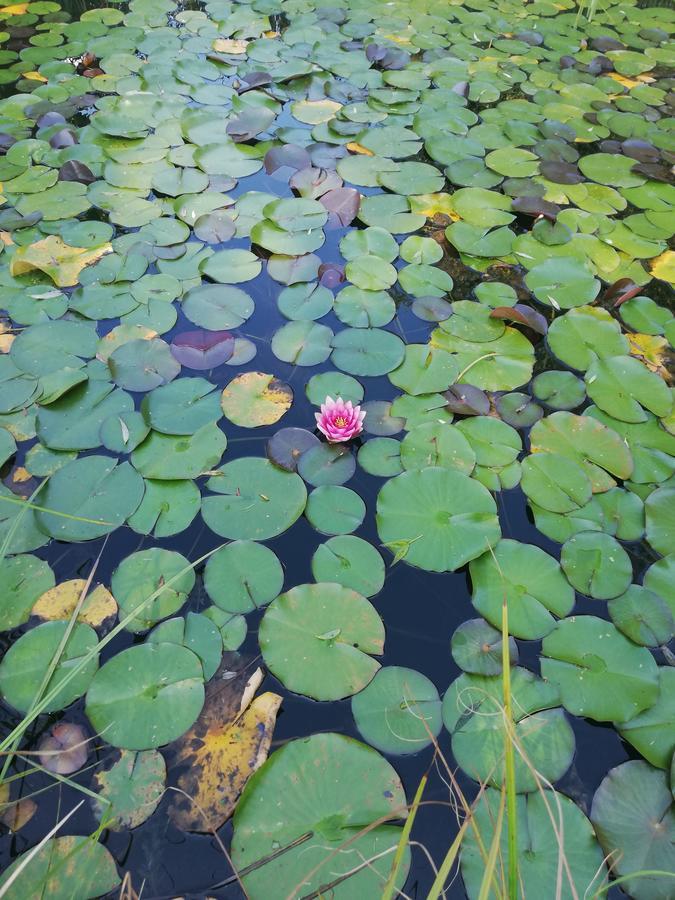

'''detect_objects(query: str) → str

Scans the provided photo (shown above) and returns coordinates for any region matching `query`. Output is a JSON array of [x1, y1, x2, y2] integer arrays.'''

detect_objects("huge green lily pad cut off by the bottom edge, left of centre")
[[232, 732, 410, 897]]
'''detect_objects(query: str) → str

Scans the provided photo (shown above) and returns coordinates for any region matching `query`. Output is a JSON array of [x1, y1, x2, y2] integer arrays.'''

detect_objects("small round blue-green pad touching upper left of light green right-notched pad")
[[204, 541, 284, 613]]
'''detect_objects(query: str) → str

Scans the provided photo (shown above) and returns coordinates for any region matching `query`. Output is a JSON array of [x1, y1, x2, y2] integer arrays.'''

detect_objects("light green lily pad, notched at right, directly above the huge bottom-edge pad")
[[258, 583, 384, 700]]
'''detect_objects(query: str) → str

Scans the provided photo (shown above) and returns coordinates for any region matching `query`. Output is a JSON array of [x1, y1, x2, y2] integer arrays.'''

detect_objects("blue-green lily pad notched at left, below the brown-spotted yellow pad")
[[202, 460, 312, 541]]
